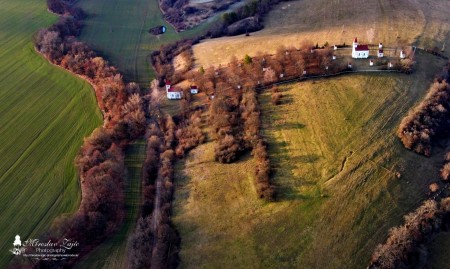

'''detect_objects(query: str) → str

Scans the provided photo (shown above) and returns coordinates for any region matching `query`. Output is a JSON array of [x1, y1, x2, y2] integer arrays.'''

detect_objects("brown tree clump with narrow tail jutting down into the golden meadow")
[[209, 84, 275, 201]]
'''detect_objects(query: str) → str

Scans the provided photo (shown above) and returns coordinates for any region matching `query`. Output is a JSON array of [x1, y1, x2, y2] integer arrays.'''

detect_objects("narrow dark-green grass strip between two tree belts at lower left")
[[76, 139, 146, 269]]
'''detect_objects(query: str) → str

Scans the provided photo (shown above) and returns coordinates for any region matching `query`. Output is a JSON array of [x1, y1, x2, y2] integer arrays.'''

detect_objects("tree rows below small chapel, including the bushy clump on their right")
[[128, 94, 206, 268]]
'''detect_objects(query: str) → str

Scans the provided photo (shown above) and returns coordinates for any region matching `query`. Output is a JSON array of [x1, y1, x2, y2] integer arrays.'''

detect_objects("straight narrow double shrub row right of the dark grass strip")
[[128, 116, 180, 268]]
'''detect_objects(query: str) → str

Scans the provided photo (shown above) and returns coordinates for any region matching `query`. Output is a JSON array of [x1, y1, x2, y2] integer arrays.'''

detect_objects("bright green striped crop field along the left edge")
[[0, 0, 101, 268]]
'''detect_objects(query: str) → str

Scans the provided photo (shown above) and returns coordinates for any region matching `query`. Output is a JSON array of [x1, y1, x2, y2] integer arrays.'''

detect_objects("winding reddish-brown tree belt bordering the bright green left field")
[[35, 0, 147, 267]]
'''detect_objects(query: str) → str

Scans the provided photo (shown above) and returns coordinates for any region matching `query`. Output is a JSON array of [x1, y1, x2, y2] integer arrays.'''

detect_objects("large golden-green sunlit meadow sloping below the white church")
[[173, 51, 445, 268]]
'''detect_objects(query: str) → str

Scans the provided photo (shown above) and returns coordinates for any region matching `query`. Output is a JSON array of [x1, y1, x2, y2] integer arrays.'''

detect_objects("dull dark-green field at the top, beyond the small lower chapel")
[[78, 0, 211, 87]]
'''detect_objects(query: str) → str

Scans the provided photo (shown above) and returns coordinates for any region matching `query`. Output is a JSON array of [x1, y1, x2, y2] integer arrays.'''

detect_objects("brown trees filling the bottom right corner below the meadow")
[[368, 198, 450, 269]]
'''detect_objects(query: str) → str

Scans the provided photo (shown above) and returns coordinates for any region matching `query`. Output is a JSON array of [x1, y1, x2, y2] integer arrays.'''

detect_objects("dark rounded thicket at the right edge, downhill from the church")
[[397, 81, 450, 156]]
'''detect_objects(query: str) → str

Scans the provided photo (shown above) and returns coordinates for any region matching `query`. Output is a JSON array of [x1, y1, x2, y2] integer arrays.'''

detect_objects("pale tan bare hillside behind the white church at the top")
[[194, 0, 450, 66]]
